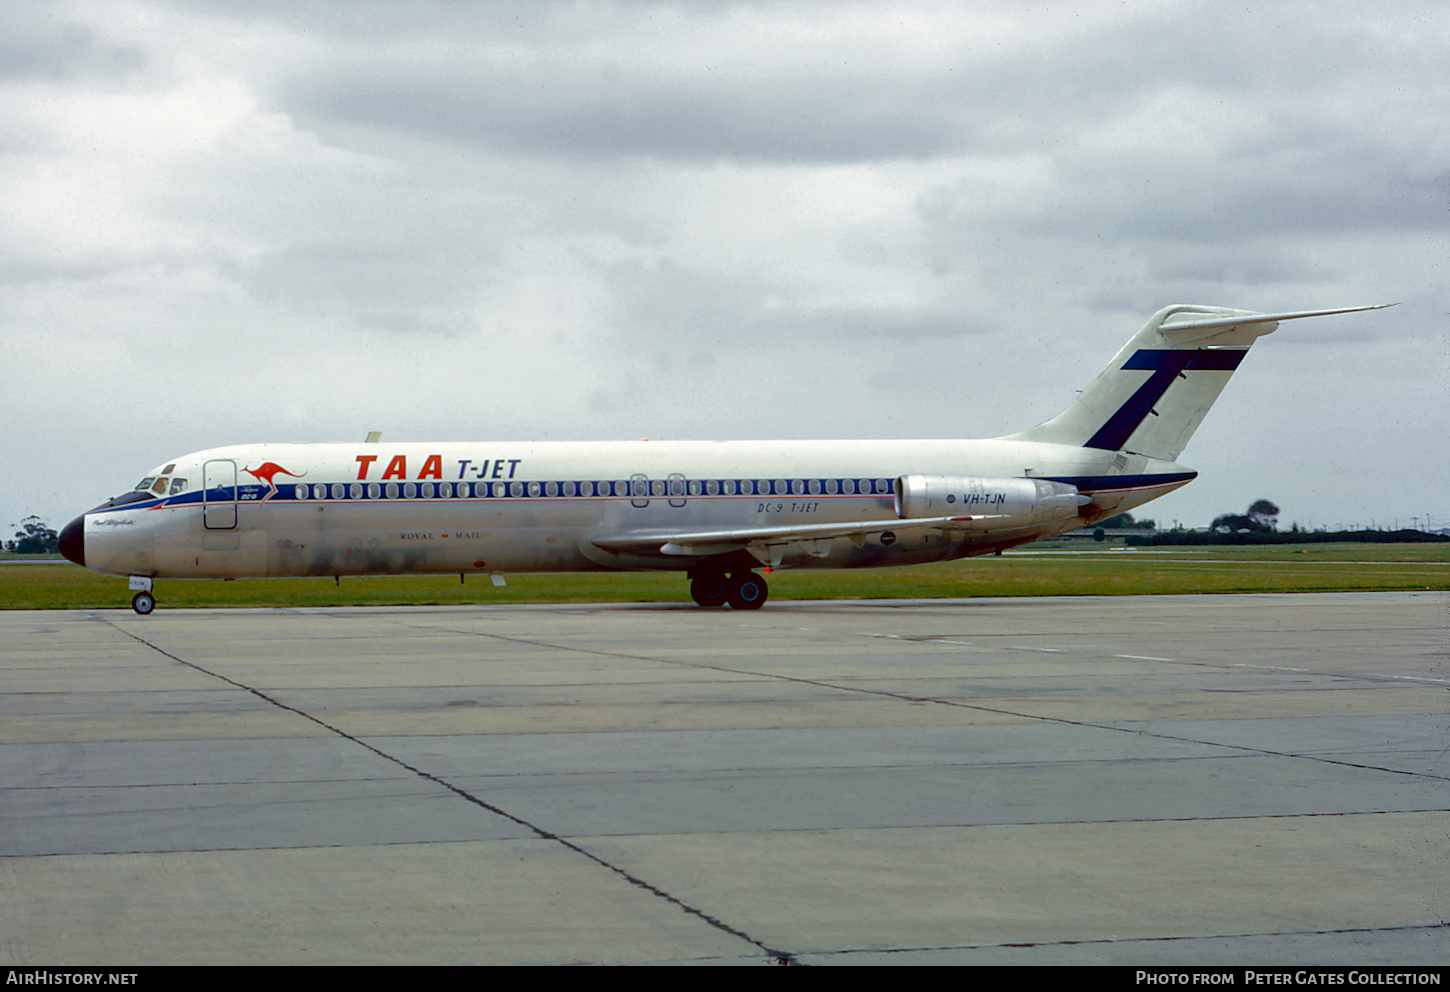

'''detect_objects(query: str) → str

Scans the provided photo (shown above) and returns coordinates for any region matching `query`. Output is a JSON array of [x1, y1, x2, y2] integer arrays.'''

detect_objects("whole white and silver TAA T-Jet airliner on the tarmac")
[[59, 306, 1379, 613]]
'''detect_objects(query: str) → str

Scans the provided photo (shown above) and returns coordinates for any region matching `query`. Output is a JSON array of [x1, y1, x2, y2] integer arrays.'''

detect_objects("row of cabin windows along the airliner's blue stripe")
[[294, 479, 892, 499]]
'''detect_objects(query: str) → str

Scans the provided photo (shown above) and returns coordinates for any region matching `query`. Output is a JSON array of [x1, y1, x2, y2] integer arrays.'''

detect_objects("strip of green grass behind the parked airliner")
[[0, 544, 1450, 609]]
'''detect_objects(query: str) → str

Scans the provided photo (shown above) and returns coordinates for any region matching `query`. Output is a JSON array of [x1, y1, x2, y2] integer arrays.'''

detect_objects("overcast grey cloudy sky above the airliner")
[[0, 0, 1450, 537]]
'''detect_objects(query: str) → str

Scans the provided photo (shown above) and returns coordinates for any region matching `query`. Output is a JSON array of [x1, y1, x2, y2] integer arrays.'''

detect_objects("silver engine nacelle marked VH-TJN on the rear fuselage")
[[896, 476, 1089, 531]]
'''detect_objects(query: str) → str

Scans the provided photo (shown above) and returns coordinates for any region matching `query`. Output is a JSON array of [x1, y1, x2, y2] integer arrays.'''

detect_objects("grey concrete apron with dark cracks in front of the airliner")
[[0, 592, 1450, 966]]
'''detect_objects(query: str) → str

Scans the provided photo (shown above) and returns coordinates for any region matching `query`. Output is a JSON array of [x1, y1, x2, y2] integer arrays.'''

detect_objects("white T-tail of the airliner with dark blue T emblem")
[[1006, 303, 1393, 461]]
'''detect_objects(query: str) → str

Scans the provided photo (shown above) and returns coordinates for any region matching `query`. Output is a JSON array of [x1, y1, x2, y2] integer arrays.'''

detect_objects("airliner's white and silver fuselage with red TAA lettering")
[[67, 439, 1195, 579]]
